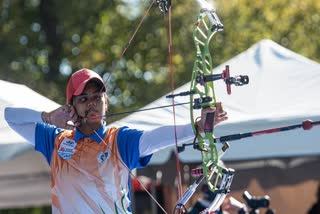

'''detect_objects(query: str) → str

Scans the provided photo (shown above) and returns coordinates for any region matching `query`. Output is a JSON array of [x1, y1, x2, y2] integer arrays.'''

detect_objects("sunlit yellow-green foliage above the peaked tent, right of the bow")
[[220, 0, 320, 62]]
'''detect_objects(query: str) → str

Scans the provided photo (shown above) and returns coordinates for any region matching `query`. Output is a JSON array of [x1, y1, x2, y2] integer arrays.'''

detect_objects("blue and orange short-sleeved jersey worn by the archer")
[[35, 123, 151, 213]]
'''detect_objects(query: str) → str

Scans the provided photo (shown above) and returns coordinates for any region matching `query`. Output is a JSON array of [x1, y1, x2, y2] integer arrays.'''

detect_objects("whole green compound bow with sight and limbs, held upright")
[[158, 0, 249, 213]]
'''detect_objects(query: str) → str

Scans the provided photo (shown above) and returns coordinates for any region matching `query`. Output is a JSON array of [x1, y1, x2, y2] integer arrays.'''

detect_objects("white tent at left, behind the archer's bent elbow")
[[0, 80, 58, 208]]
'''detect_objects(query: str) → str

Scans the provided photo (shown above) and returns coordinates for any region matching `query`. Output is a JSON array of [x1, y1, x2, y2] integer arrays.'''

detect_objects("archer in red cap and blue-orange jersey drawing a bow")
[[5, 68, 227, 214]]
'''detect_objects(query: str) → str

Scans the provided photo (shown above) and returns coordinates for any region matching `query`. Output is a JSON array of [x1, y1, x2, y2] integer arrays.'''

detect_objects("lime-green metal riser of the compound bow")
[[190, 10, 226, 191]]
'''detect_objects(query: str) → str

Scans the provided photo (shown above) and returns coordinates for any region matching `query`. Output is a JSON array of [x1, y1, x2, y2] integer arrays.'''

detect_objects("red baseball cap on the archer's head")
[[66, 68, 106, 103]]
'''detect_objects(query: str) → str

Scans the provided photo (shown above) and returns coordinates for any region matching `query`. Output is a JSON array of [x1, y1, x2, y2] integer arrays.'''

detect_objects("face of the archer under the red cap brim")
[[73, 81, 107, 124]]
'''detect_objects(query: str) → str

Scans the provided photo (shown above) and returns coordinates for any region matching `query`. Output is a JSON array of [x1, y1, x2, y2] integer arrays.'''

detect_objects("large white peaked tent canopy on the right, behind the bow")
[[112, 40, 320, 164]]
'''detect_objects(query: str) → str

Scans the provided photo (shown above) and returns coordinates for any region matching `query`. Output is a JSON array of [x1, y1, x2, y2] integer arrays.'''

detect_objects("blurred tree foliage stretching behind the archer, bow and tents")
[[0, 0, 320, 214]]
